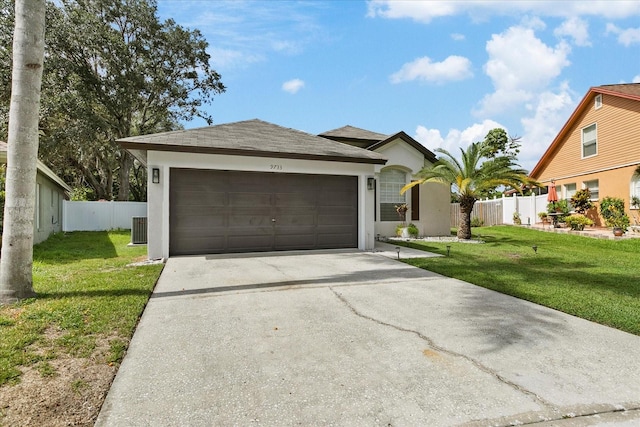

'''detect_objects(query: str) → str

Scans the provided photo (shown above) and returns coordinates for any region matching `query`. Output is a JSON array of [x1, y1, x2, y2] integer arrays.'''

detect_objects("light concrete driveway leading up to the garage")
[[96, 247, 640, 426]]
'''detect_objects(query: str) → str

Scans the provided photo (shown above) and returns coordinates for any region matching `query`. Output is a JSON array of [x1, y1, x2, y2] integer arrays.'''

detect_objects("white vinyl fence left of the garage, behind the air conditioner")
[[62, 200, 147, 231]]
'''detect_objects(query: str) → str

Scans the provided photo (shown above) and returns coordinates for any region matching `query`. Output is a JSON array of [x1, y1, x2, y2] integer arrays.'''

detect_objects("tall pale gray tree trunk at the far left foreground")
[[0, 0, 45, 304]]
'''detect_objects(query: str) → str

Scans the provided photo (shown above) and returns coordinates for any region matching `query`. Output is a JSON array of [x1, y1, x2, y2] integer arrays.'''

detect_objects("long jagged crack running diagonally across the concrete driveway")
[[329, 287, 558, 410]]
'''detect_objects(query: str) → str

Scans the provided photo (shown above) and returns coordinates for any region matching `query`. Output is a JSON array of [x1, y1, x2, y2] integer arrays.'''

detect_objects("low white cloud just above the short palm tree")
[[414, 120, 505, 158]]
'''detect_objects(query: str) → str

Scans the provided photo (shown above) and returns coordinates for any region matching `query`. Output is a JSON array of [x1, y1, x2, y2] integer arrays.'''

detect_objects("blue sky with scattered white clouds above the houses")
[[158, 0, 640, 170]]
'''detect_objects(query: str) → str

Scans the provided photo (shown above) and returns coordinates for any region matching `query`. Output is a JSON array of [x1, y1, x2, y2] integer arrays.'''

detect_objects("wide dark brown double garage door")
[[169, 169, 358, 255]]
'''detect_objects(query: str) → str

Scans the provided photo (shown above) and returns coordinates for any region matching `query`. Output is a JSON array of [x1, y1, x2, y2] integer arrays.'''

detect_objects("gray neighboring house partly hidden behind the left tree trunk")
[[0, 141, 71, 244]]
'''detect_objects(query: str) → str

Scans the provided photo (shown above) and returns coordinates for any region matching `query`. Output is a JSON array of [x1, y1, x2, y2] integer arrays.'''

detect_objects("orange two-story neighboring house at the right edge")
[[530, 83, 640, 225]]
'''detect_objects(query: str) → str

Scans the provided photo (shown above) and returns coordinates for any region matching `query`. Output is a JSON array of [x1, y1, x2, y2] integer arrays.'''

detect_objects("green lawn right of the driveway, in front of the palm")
[[398, 226, 640, 335]]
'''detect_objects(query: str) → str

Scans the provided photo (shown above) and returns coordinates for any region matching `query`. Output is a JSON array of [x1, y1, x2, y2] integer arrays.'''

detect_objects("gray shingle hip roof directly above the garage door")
[[118, 119, 386, 164]]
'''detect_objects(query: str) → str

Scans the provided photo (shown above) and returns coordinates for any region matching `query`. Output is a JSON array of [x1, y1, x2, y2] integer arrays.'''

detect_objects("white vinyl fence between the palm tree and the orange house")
[[451, 194, 548, 227]]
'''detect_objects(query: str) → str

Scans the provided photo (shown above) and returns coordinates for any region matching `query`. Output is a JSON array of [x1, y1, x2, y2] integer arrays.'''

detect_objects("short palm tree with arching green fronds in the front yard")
[[401, 142, 532, 239]]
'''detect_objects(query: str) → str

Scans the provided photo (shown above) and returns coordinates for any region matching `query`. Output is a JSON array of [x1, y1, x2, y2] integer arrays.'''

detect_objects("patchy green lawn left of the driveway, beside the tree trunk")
[[0, 231, 162, 385]]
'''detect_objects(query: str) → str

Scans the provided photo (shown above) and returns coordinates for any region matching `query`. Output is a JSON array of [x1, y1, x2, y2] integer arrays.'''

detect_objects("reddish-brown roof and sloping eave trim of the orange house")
[[529, 83, 640, 179]]
